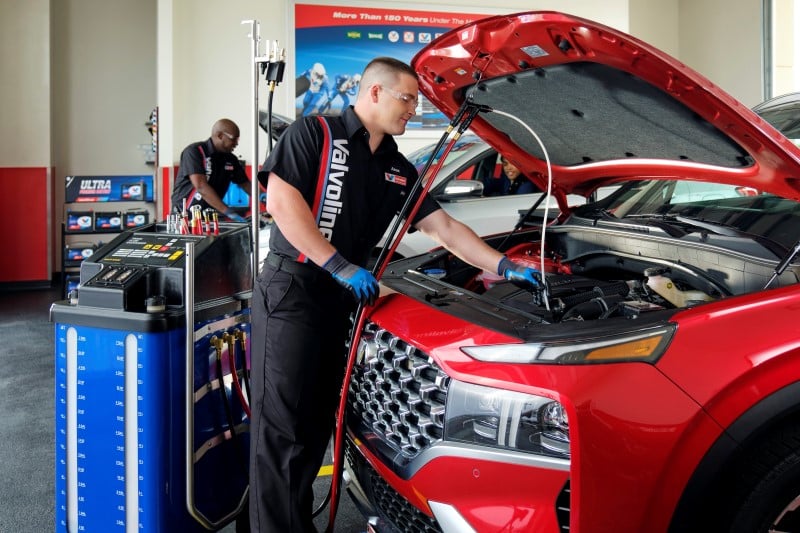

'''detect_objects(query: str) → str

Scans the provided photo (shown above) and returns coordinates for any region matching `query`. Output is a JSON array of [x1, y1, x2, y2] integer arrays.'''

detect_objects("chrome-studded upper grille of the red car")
[[348, 322, 450, 459]]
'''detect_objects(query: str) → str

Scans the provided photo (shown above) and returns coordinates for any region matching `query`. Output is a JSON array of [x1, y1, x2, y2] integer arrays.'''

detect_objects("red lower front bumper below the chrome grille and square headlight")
[[345, 436, 570, 533]]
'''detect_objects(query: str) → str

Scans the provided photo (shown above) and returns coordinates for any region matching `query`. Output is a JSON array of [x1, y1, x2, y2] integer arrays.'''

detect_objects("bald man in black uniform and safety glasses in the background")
[[172, 118, 250, 222]]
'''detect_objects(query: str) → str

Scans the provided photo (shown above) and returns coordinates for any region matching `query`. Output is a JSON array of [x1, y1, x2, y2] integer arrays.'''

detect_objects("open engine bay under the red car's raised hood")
[[387, 229, 748, 324]]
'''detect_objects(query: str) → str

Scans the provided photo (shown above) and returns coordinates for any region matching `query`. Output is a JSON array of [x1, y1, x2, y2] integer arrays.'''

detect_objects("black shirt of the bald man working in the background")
[[172, 137, 248, 211]]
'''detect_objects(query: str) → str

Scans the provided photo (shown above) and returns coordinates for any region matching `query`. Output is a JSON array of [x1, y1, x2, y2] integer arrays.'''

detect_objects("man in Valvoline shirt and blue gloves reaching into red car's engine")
[[250, 57, 537, 533]]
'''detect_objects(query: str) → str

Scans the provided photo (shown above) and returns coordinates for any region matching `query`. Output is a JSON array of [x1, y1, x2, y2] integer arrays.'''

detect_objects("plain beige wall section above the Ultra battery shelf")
[[52, 0, 157, 179]]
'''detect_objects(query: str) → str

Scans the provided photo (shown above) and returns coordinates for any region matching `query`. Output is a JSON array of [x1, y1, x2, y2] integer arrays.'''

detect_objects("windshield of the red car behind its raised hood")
[[576, 180, 800, 252]]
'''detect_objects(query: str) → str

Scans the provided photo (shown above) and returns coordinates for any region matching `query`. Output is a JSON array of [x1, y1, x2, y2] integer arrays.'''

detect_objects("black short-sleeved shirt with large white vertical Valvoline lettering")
[[259, 106, 440, 265]]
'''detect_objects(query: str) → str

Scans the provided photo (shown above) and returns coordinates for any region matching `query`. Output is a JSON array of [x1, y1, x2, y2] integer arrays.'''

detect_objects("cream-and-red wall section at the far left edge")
[[0, 0, 54, 283]]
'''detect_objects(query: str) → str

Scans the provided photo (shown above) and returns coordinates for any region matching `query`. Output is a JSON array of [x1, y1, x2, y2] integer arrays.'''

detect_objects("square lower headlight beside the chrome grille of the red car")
[[444, 380, 569, 459]]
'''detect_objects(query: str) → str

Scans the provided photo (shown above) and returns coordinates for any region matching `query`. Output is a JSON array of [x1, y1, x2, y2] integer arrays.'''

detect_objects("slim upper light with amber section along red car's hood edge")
[[462, 324, 675, 365]]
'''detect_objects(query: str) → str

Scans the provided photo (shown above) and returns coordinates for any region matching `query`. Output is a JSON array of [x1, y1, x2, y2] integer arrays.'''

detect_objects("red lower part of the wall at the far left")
[[0, 167, 50, 283]]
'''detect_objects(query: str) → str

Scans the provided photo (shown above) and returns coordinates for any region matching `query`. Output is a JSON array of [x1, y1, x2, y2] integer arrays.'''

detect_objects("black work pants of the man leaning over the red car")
[[250, 263, 355, 533]]
